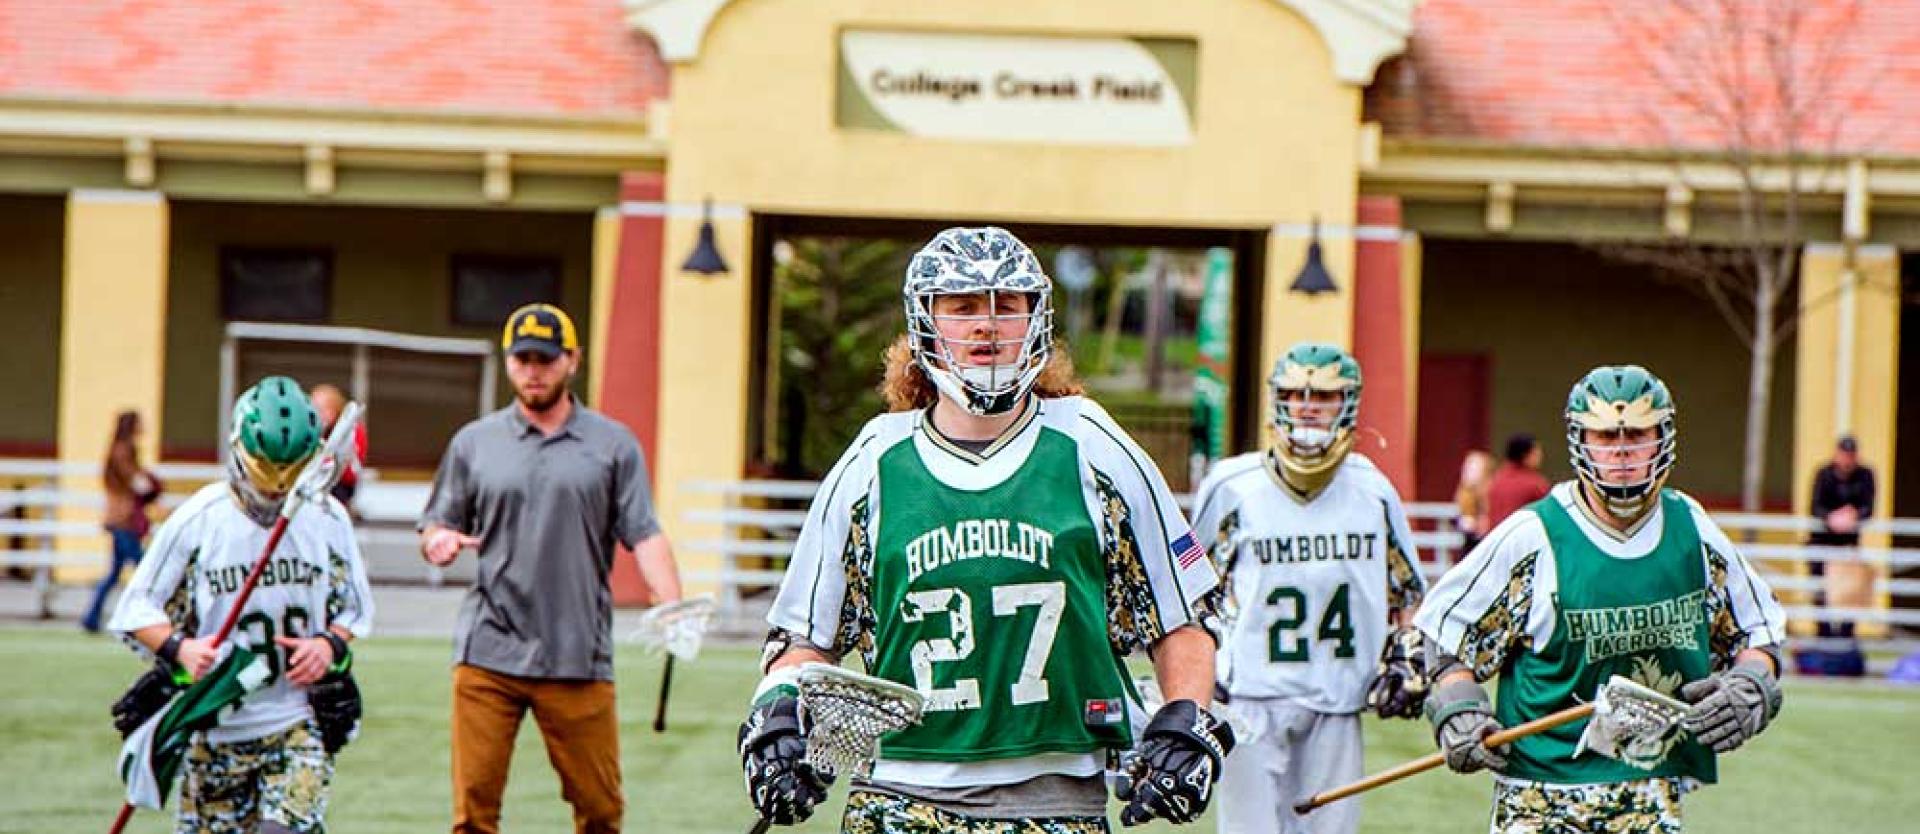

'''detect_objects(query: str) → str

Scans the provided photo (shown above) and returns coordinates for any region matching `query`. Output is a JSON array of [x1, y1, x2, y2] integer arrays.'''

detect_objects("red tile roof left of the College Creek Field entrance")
[[0, 0, 668, 115]]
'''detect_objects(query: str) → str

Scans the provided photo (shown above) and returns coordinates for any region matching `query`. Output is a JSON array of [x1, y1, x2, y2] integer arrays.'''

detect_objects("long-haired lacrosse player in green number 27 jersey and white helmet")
[[739, 227, 1233, 832]]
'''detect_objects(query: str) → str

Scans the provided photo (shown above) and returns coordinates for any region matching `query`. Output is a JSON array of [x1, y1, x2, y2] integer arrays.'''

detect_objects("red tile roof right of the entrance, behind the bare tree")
[[1367, 0, 1920, 156]]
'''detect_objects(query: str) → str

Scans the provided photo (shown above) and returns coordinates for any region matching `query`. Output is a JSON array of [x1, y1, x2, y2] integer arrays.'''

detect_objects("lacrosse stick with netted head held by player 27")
[[753, 663, 925, 834]]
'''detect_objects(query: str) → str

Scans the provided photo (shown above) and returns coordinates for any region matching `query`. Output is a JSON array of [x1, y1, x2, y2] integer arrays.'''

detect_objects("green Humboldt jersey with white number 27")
[[874, 430, 1129, 761]]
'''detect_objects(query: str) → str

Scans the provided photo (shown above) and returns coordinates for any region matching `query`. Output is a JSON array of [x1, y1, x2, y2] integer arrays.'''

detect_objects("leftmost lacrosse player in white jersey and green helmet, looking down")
[[109, 377, 372, 832]]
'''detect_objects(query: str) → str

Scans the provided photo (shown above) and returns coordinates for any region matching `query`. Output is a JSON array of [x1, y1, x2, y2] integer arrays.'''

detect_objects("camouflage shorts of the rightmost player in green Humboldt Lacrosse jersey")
[[1490, 778, 1682, 834]]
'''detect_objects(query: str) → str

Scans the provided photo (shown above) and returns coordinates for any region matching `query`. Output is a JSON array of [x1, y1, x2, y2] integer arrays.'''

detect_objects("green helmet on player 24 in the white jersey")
[[1267, 342, 1361, 494]]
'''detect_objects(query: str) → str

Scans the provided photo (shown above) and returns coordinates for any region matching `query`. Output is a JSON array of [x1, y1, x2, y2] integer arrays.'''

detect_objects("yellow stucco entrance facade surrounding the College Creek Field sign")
[[657, 0, 1359, 588]]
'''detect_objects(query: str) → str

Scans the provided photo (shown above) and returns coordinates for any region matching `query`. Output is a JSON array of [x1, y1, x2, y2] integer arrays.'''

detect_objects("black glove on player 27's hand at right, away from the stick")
[[1116, 699, 1233, 826]]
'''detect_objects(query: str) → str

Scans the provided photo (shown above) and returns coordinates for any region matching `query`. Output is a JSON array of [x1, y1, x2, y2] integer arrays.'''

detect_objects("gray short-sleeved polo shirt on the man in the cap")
[[420, 400, 660, 680]]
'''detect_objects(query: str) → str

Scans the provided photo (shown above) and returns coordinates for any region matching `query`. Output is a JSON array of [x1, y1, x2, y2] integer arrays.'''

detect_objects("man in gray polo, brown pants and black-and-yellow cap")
[[420, 304, 680, 834]]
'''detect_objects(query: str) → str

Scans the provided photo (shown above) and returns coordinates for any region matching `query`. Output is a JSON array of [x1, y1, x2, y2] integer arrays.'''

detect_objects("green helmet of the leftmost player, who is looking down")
[[227, 377, 321, 523]]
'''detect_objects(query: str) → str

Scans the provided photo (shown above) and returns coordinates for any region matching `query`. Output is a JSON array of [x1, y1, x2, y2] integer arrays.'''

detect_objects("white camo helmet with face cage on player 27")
[[900, 227, 1054, 415]]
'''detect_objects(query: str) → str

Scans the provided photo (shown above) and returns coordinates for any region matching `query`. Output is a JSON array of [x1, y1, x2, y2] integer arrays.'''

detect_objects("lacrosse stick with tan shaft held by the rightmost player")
[[1294, 675, 1686, 813]]
